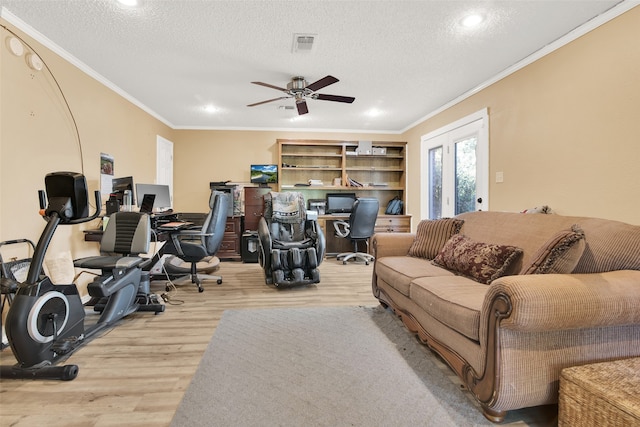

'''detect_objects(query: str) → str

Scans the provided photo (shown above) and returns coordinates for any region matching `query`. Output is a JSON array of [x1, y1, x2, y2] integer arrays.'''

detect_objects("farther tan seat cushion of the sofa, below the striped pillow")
[[375, 256, 453, 296]]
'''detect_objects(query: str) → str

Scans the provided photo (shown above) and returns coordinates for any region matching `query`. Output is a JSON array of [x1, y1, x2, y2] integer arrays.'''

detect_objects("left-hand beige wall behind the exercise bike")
[[0, 21, 174, 257]]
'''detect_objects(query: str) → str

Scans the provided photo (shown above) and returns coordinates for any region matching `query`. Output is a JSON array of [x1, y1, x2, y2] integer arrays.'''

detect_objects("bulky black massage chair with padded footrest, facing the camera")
[[258, 191, 325, 287]]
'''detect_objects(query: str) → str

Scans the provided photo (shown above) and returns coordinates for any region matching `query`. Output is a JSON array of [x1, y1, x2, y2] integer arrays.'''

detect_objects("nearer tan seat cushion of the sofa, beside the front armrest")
[[409, 276, 489, 341]]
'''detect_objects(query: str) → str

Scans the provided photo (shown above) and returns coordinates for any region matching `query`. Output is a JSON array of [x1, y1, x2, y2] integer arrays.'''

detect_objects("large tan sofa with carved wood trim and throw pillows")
[[372, 212, 640, 422]]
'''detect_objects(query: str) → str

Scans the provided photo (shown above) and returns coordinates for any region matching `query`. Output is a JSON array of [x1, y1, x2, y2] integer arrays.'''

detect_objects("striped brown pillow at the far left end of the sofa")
[[408, 218, 464, 259]]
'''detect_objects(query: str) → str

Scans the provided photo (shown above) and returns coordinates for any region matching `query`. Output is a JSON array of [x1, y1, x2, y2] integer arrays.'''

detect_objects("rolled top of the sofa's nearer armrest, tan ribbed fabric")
[[480, 270, 640, 331]]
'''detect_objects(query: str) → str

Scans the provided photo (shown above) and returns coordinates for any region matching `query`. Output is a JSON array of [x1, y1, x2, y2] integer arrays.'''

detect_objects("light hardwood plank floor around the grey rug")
[[0, 258, 378, 427]]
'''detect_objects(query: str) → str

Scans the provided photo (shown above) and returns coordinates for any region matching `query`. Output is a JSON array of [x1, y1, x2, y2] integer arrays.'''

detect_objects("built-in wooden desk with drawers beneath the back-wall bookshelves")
[[318, 214, 411, 256]]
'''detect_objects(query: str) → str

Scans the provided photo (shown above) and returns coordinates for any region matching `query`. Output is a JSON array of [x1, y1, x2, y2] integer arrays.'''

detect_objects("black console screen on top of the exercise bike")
[[44, 172, 89, 220]]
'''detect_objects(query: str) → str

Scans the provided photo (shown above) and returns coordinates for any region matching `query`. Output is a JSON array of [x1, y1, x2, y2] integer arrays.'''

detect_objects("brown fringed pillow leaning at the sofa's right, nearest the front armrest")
[[520, 224, 586, 274]]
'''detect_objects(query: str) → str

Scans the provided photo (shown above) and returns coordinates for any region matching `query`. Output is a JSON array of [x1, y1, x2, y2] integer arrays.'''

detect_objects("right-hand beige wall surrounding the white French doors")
[[404, 7, 640, 226]]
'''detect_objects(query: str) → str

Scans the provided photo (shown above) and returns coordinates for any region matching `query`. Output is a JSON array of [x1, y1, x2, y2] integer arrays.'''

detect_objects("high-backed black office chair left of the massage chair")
[[162, 190, 231, 292]]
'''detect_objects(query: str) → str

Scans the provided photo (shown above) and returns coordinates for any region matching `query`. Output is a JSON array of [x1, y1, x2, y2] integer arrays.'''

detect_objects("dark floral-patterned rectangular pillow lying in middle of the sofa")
[[433, 234, 522, 285]]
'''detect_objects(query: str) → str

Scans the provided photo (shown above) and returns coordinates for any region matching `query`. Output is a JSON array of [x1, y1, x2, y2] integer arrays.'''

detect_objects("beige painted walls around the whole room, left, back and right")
[[0, 7, 640, 257]]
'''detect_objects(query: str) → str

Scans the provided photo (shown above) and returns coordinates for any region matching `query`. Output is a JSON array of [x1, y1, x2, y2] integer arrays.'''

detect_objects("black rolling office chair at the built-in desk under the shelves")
[[333, 197, 380, 265]]
